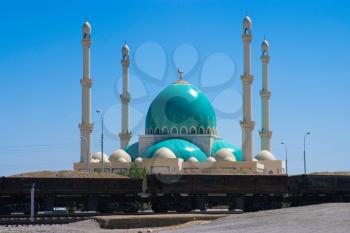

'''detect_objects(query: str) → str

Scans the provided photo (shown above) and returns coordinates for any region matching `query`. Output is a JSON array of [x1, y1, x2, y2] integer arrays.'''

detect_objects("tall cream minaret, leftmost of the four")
[[79, 22, 94, 163]]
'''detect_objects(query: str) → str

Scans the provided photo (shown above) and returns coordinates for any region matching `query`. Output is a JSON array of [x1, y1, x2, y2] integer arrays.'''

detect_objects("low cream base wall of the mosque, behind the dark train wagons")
[[74, 157, 285, 175]]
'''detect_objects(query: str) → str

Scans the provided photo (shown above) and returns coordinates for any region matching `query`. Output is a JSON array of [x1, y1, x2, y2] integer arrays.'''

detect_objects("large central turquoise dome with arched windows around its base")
[[145, 80, 216, 134]]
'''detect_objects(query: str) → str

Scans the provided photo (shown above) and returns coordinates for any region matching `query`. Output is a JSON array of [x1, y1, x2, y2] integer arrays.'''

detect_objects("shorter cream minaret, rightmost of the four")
[[259, 40, 272, 151]]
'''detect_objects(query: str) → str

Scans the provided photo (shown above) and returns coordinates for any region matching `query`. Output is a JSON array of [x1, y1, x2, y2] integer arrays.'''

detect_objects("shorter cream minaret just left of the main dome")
[[119, 43, 131, 149]]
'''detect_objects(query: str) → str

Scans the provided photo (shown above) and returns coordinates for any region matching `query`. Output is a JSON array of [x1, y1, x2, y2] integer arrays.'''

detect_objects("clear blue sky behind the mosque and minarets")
[[0, 0, 350, 175]]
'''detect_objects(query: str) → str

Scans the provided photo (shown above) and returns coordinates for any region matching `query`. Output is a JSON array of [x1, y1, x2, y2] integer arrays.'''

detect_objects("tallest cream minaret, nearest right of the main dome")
[[240, 16, 255, 161]]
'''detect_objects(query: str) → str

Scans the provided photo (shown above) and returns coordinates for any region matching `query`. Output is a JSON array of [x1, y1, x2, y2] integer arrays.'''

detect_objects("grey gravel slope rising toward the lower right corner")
[[160, 203, 350, 233]]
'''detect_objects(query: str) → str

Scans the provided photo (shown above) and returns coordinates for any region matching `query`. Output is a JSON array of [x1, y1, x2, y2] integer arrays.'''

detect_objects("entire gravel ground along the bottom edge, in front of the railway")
[[0, 203, 350, 233]]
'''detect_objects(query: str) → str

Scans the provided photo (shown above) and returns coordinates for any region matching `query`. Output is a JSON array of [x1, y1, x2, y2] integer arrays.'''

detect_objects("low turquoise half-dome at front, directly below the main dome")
[[143, 139, 207, 161]]
